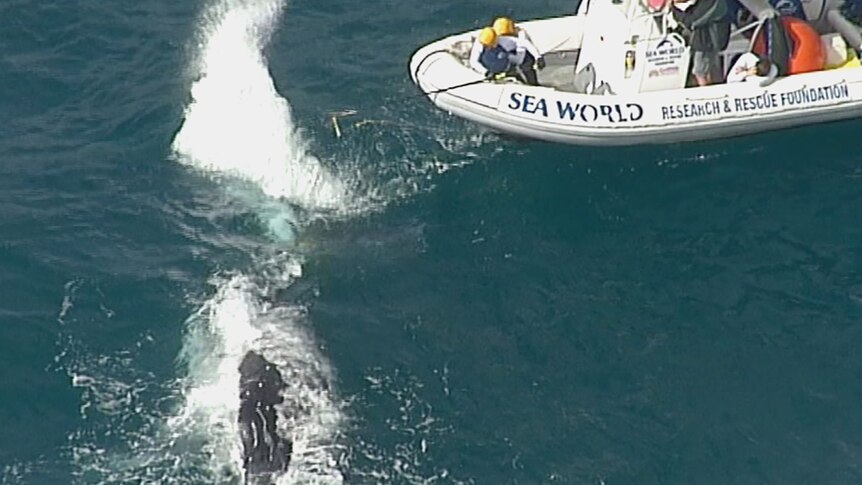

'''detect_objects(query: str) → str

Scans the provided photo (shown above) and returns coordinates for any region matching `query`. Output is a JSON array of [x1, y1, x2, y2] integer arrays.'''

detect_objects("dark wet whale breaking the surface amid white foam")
[[237, 350, 293, 485]]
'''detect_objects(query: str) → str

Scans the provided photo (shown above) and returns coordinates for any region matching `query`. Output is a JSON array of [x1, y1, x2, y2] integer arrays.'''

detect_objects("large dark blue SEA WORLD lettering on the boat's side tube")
[[507, 92, 644, 123]]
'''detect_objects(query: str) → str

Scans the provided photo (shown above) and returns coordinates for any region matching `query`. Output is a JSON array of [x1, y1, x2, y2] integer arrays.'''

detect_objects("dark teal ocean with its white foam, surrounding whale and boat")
[[5, 0, 862, 485]]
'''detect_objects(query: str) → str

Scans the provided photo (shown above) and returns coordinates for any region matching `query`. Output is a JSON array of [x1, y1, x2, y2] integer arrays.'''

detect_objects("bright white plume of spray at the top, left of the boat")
[[172, 0, 350, 214]]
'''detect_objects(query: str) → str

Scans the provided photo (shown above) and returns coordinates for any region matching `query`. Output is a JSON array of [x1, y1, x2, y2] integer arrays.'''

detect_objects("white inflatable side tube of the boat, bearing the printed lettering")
[[410, 21, 862, 146]]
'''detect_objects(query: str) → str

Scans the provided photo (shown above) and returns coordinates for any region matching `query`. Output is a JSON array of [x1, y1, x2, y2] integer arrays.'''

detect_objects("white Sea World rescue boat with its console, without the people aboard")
[[410, 0, 862, 145]]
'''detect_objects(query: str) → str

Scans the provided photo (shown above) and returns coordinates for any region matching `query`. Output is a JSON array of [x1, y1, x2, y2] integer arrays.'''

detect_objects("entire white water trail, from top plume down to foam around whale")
[[168, 0, 352, 483]]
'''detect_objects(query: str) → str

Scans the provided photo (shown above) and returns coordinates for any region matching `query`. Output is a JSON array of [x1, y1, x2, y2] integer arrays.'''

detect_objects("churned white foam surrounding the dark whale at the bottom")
[[174, 270, 343, 483]]
